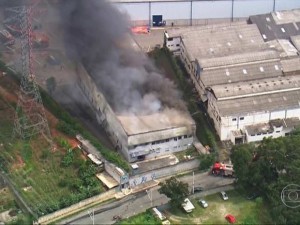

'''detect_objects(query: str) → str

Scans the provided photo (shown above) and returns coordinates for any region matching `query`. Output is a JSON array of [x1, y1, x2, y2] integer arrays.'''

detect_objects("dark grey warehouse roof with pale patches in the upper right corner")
[[249, 9, 300, 41]]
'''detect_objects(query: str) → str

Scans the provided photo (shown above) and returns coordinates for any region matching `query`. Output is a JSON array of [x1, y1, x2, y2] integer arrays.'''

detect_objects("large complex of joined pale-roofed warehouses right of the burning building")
[[165, 10, 300, 144]]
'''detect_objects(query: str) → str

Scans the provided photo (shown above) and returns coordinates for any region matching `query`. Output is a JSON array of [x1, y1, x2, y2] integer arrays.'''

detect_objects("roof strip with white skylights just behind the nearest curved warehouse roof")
[[200, 59, 282, 87]]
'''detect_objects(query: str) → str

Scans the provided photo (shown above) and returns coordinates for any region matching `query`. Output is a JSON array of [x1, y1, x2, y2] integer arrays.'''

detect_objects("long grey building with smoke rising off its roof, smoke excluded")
[[77, 62, 196, 162]]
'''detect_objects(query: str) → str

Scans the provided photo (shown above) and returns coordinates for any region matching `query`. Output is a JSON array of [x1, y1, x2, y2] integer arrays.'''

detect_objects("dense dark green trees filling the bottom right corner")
[[231, 133, 300, 224]]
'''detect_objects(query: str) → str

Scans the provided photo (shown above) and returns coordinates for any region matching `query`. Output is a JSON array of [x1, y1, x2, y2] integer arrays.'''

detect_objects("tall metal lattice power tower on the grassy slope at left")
[[14, 6, 52, 144]]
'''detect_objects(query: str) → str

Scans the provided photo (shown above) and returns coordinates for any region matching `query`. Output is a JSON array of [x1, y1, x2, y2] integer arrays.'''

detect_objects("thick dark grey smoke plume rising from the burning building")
[[60, 0, 186, 115]]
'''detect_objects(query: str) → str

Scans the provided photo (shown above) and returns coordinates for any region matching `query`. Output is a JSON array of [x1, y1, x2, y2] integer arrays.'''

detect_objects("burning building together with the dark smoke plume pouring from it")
[[61, 0, 196, 162]]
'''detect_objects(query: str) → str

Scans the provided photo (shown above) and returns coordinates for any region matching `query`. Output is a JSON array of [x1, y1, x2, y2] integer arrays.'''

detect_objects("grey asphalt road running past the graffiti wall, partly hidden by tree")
[[60, 173, 233, 224]]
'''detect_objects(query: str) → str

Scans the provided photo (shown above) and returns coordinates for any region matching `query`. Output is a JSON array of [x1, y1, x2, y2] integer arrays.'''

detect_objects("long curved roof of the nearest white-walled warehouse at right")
[[211, 76, 300, 101]]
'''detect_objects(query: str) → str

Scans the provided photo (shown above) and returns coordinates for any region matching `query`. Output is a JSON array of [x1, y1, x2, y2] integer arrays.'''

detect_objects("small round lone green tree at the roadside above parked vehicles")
[[158, 177, 189, 207]]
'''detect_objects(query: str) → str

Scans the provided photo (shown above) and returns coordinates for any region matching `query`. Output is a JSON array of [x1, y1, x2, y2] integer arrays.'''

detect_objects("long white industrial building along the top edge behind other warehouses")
[[110, 0, 300, 26]]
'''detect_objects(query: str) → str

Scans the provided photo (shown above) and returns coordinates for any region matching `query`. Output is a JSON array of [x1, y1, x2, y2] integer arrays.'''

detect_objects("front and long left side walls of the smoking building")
[[77, 66, 196, 162]]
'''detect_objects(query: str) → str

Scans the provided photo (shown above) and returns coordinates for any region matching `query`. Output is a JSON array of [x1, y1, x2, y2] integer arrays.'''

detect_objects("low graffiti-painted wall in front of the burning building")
[[129, 159, 199, 188]]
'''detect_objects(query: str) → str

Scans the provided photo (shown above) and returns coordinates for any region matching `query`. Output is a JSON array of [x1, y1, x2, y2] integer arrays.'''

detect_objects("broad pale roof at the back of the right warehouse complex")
[[181, 24, 266, 61]]
